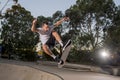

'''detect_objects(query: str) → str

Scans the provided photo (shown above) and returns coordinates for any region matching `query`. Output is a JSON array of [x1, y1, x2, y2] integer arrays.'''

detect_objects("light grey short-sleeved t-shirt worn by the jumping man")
[[37, 26, 55, 45]]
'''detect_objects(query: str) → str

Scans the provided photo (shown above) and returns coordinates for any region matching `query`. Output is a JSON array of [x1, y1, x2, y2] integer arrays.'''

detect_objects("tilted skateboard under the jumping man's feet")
[[58, 40, 72, 68]]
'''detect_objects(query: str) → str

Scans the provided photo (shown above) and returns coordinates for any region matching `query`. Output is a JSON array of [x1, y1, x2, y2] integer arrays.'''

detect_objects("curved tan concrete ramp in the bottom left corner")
[[0, 63, 61, 80]]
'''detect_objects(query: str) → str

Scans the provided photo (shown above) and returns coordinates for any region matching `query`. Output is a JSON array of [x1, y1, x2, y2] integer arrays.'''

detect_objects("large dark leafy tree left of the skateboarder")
[[2, 5, 37, 57]]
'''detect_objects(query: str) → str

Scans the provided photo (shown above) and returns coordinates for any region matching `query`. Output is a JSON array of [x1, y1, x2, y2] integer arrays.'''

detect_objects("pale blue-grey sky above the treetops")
[[0, 0, 120, 17]]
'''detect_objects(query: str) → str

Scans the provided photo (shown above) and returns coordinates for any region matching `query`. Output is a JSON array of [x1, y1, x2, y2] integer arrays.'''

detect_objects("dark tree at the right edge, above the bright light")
[[106, 6, 120, 50]]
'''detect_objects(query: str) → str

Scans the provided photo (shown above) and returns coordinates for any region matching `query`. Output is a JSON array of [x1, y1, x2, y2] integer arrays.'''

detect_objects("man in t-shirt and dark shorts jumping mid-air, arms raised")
[[31, 17, 69, 64]]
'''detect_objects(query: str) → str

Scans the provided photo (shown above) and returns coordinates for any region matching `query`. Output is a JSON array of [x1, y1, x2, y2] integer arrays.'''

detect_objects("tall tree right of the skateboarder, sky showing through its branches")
[[66, 0, 116, 50]]
